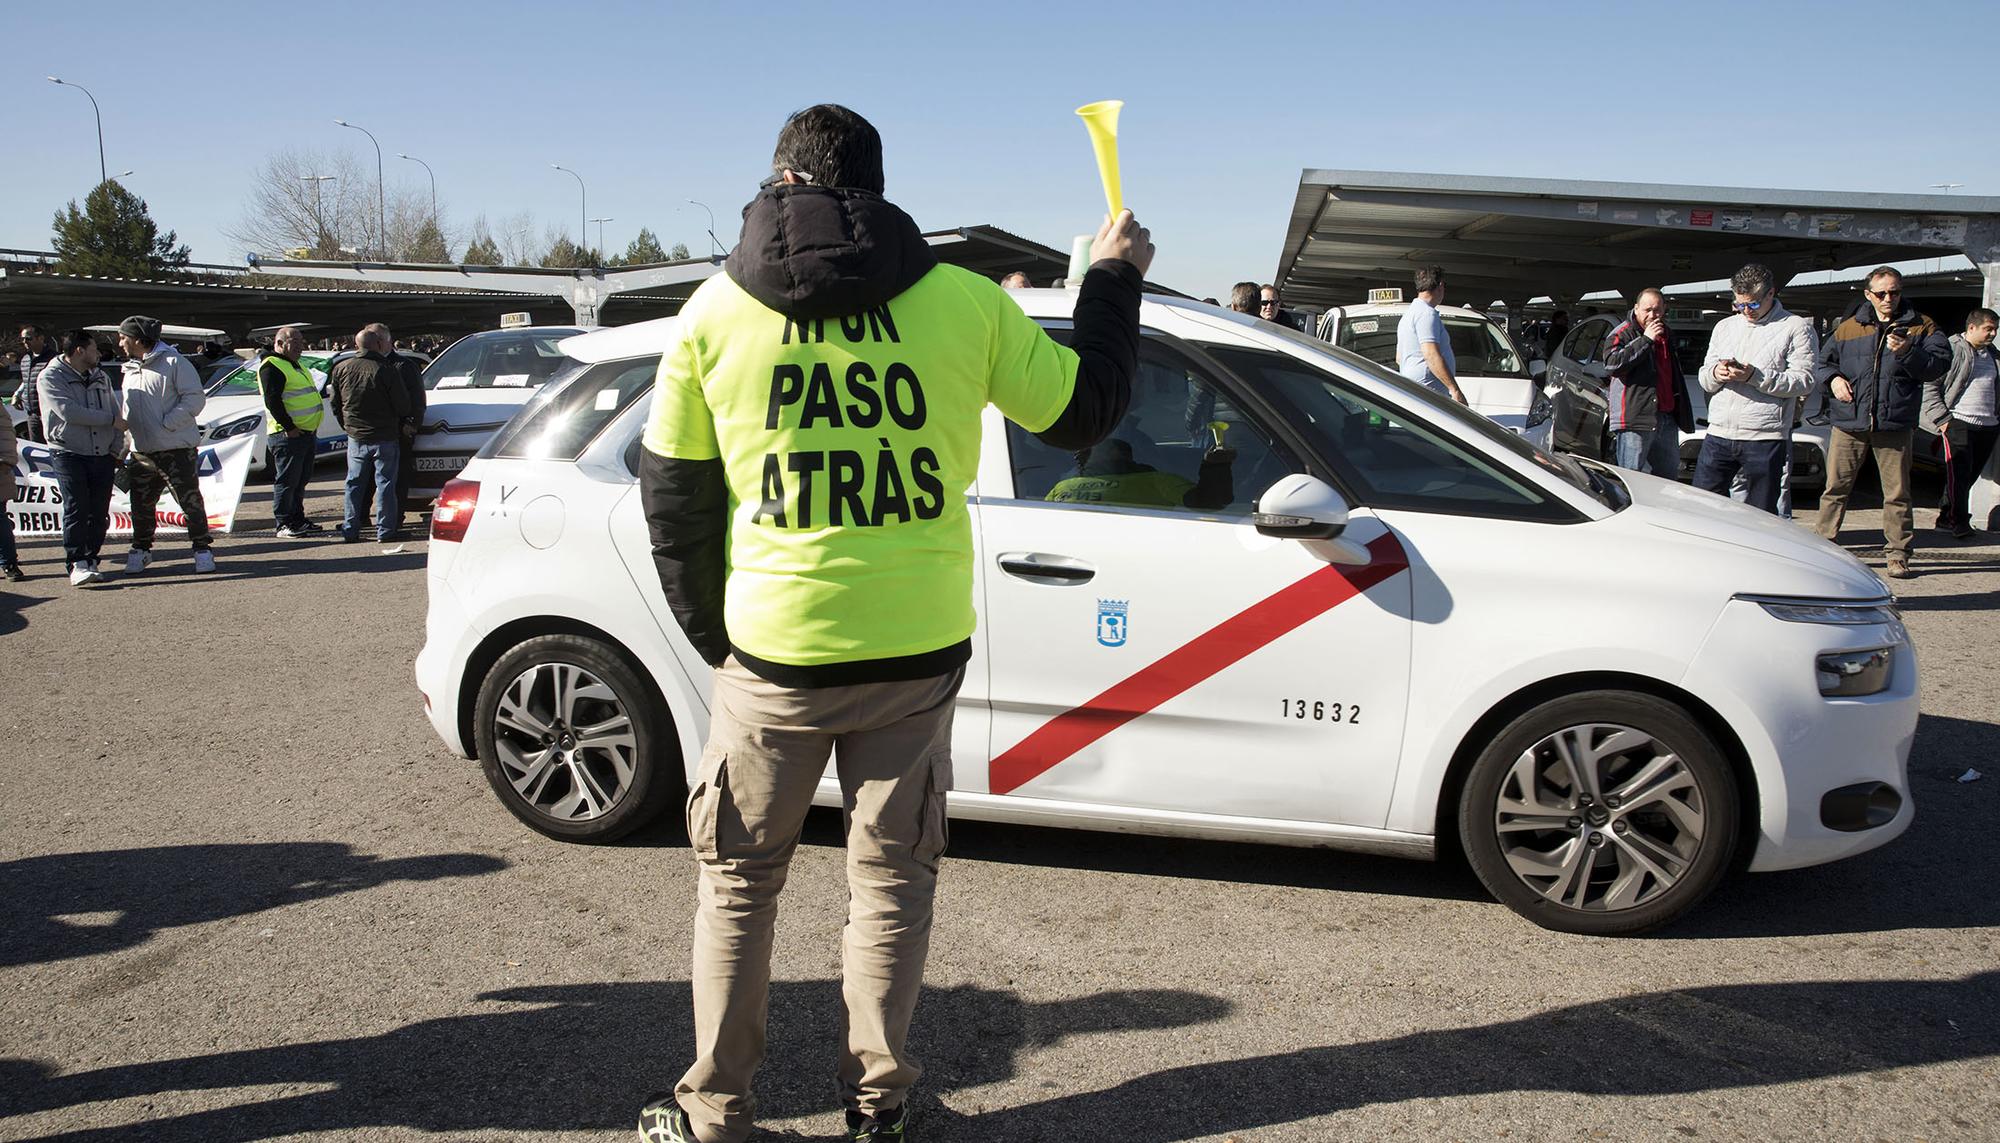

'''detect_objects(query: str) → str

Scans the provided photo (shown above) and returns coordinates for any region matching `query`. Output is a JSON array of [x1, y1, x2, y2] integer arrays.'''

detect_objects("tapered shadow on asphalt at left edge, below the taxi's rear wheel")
[[0, 841, 508, 967]]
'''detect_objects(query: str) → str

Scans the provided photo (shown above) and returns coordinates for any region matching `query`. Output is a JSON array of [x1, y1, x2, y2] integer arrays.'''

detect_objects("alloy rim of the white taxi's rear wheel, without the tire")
[[494, 663, 638, 823]]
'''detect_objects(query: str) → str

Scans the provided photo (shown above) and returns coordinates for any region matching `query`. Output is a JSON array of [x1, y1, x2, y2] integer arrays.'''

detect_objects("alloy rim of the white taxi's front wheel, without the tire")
[[1494, 723, 1708, 913]]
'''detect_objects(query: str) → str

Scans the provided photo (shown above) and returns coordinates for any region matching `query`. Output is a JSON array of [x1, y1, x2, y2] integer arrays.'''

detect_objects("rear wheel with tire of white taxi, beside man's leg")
[[472, 635, 686, 841]]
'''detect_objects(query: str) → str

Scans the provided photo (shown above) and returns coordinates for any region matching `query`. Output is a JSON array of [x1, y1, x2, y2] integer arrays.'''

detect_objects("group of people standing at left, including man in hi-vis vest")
[[0, 316, 426, 587]]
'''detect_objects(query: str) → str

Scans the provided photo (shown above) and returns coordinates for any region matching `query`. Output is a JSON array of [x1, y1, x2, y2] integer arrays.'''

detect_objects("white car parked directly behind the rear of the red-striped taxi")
[[404, 326, 582, 502]]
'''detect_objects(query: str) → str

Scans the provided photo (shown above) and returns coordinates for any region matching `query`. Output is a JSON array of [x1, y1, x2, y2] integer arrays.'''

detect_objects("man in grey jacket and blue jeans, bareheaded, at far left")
[[36, 330, 126, 587]]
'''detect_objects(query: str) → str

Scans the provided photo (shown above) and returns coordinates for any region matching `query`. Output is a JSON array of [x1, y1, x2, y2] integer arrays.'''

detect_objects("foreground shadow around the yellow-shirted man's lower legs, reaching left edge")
[[0, 981, 1230, 1143]]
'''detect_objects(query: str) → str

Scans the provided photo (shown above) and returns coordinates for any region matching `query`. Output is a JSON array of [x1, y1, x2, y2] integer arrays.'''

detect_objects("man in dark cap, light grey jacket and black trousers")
[[118, 318, 216, 575]]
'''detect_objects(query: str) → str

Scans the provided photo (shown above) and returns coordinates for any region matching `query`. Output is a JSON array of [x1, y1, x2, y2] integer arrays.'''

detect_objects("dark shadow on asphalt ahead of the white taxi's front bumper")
[[1654, 715, 2000, 939]]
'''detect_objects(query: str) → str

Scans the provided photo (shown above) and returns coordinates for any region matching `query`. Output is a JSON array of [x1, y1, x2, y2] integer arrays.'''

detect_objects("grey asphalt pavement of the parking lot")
[[0, 470, 2000, 1143]]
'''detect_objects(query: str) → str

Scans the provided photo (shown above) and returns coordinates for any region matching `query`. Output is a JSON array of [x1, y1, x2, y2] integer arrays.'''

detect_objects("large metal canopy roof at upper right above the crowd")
[[1274, 170, 2000, 308]]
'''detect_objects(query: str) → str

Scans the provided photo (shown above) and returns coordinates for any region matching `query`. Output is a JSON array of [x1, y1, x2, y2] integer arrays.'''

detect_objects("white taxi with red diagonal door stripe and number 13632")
[[416, 290, 1918, 933]]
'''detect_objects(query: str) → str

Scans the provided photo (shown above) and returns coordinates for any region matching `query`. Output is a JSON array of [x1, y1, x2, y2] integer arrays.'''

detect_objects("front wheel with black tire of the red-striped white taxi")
[[1458, 691, 1740, 935]]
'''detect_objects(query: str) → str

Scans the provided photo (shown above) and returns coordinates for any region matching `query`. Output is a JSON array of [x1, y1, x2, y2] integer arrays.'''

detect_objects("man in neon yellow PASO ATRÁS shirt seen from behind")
[[640, 104, 1152, 1143]]
